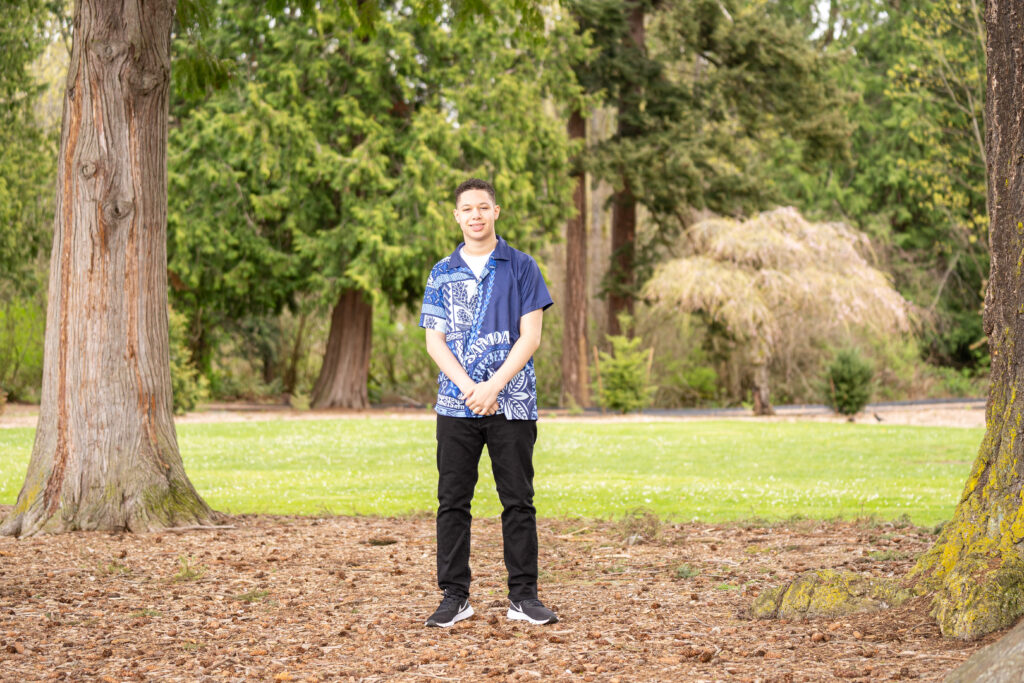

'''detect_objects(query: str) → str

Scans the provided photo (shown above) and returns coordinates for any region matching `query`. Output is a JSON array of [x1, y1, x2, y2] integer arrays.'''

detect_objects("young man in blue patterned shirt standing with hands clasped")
[[420, 178, 558, 628]]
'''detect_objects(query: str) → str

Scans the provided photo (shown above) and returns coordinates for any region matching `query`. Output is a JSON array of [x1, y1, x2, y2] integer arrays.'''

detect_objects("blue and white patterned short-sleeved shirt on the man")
[[420, 237, 552, 420]]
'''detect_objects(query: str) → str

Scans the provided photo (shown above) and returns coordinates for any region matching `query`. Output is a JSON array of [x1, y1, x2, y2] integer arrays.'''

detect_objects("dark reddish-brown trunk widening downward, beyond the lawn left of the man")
[[312, 290, 374, 410]]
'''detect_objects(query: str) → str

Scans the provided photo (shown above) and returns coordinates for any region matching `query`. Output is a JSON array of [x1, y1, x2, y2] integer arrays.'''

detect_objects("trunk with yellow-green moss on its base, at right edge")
[[913, 0, 1024, 639]]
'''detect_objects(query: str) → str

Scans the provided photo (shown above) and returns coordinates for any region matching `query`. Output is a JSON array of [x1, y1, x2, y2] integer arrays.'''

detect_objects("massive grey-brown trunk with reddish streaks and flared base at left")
[[0, 0, 217, 536]]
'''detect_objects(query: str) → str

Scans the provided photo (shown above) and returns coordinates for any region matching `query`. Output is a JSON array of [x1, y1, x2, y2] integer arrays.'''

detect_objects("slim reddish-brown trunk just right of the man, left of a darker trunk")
[[562, 105, 590, 408]]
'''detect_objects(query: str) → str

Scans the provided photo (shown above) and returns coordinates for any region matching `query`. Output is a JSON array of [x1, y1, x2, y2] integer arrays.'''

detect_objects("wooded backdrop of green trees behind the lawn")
[[0, 0, 988, 417]]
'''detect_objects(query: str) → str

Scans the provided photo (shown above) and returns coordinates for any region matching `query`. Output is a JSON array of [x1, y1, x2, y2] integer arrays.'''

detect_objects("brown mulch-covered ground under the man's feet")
[[0, 506, 1000, 682]]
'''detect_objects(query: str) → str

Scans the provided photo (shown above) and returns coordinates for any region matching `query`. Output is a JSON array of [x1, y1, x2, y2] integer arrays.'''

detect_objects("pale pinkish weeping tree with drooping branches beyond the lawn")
[[644, 208, 910, 415]]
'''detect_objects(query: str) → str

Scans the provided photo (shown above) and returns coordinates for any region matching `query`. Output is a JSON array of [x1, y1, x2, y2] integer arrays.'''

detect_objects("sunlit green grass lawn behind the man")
[[0, 419, 982, 525]]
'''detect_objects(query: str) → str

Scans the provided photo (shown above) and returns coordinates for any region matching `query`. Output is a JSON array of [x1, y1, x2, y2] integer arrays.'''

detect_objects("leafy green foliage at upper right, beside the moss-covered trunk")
[[768, 0, 988, 369]]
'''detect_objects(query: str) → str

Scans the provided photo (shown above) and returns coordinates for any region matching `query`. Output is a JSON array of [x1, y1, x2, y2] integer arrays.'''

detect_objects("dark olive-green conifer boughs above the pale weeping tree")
[[569, 0, 849, 295]]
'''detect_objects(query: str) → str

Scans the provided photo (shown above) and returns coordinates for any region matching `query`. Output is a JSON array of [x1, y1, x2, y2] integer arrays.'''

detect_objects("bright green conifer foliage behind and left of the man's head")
[[169, 1, 574, 385]]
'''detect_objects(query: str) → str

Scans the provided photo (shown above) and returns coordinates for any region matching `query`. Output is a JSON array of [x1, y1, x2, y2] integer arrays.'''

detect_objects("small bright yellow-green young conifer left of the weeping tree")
[[594, 315, 657, 414]]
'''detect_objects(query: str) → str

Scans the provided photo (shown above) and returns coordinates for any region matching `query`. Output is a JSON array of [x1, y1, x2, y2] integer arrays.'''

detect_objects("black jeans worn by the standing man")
[[437, 415, 537, 602]]
